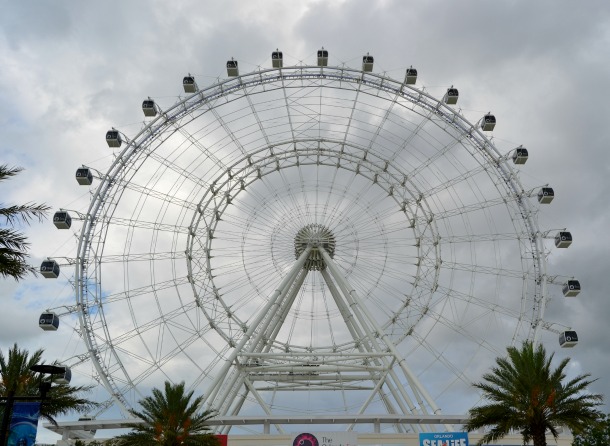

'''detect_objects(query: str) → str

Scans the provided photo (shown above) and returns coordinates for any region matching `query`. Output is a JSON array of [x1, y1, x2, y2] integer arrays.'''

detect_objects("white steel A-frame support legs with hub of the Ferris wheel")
[[206, 224, 440, 433]]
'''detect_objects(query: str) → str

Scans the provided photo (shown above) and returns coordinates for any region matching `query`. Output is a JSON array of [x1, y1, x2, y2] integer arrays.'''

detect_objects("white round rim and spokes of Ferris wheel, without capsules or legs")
[[77, 67, 545, 424]]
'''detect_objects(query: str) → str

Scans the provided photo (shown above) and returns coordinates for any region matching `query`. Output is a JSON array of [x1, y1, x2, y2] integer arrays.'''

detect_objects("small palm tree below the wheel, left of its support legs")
[[113, 381, 219, 446]]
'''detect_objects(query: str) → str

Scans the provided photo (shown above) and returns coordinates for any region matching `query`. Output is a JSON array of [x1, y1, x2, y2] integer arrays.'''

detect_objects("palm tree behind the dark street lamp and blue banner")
[[0, 344, 97, 424]]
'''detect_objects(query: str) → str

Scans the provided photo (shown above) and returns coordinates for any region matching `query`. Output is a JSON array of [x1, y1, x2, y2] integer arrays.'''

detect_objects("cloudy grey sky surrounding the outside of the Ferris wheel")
[[0, 0, 610, 442]]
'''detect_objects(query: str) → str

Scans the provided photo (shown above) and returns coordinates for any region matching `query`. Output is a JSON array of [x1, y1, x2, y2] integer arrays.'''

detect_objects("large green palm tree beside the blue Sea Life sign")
[[465, 341, 603, 446]]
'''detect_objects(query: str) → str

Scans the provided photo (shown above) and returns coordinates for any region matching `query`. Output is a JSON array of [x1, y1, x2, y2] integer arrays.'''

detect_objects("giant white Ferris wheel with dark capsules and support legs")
[[41, 50, 580, 430]]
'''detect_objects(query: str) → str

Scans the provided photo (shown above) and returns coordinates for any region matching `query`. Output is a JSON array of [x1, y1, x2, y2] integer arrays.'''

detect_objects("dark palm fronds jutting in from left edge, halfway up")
[[0, 165, 50, 280]]
